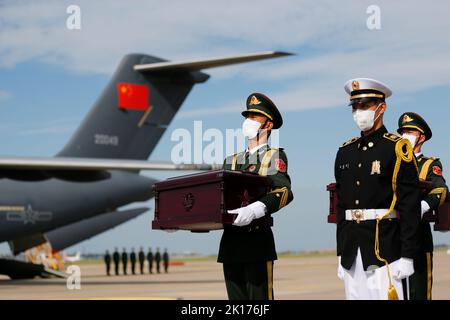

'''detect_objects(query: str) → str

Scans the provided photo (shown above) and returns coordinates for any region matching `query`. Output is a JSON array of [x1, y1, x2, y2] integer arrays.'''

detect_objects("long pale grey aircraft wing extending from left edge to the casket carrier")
[[0, 157, 222, 171]]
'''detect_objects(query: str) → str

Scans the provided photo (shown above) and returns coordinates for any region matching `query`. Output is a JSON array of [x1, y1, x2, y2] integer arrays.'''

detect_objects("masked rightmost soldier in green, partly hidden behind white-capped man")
[[397, 112, 448, 300]]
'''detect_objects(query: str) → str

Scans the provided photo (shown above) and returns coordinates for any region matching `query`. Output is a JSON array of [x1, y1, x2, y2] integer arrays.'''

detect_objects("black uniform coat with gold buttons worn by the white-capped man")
[[334, 126, 420, 270]]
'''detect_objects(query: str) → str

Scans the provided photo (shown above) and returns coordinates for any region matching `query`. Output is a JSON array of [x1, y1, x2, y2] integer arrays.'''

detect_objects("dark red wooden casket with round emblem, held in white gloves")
[[152, 170, 273, 232]]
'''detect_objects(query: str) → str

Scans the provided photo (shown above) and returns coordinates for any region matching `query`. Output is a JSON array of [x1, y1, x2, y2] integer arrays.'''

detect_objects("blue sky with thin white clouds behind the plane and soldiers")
[[0, 0, 450, 254]]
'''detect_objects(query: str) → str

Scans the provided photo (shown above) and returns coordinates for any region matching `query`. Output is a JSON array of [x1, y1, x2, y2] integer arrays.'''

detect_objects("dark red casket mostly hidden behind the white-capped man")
[[327, 181, 450, 232]]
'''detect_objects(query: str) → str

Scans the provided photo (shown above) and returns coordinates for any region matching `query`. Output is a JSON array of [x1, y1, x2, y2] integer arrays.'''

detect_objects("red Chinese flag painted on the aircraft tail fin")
[[117, 82, 149, 111]]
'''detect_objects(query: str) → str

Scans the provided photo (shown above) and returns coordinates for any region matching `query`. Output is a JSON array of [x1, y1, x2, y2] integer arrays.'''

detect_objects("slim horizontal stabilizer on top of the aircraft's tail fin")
[[134, 51, 292, 73]]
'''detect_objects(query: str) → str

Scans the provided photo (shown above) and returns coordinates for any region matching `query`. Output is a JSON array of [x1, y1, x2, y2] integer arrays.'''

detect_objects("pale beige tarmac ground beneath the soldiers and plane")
[[0, 251, 450, 300]]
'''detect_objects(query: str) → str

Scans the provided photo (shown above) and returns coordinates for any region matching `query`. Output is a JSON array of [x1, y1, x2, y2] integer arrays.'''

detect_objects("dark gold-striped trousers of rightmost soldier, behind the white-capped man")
[[409, 252, 433, 300]]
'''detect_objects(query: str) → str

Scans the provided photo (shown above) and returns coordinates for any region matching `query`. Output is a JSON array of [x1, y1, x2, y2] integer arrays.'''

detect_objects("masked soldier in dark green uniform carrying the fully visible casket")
[[218, 93, 293, 300]]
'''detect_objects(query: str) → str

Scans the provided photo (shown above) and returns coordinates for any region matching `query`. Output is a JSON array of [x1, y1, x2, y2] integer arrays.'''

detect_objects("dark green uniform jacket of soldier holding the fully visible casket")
[[218, 145, 294, 263]]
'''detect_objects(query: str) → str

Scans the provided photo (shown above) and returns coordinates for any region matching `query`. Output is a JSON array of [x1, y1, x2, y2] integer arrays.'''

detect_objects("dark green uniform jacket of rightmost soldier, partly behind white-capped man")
[[417, 154, 448, 252]]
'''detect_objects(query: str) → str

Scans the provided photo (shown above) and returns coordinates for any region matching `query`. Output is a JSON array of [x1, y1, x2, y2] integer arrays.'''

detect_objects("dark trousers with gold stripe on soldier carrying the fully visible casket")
[[223, 261, 273, 300]]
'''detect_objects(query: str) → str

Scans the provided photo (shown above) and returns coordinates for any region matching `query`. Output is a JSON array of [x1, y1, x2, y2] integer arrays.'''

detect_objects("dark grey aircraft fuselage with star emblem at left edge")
[[0, 171, 156, 242]]
